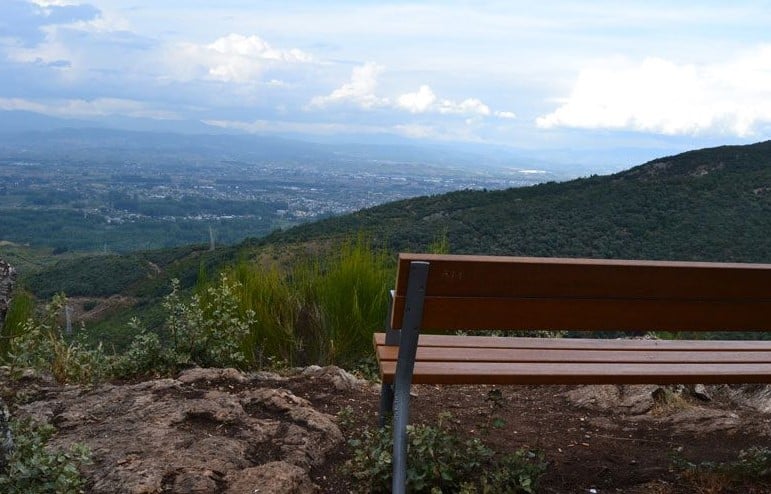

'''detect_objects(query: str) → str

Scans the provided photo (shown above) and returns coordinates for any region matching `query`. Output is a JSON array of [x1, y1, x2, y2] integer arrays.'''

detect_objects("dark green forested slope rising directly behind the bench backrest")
[[268, 141, 771, 261]]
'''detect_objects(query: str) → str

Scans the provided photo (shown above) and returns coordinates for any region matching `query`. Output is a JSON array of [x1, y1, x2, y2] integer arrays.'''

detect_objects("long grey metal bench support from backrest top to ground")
[[391, 261, 428, 494]]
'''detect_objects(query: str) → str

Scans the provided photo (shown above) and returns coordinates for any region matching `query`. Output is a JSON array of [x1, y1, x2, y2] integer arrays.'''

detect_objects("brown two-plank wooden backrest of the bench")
[[391, 254, 771, 331]]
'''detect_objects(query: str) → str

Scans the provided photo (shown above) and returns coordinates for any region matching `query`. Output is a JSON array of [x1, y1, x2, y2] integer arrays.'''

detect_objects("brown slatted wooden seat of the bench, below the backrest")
[[375, 333, 771, 384]]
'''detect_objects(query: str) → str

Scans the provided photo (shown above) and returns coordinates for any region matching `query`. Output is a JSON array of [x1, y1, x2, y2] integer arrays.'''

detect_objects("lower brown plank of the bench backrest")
[[392, 295, 771, 331]]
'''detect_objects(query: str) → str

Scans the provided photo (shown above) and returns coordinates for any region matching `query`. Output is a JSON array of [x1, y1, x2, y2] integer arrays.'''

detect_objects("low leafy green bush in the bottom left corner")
[[0, 420, 91, 494]]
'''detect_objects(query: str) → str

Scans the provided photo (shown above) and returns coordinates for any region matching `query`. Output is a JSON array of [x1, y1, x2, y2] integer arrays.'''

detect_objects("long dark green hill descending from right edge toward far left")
[[10, 141, 771, 322]]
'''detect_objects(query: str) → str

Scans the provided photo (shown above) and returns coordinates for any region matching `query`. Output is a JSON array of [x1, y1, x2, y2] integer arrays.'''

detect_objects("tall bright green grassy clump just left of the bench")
[[197, 236, 395, 368]]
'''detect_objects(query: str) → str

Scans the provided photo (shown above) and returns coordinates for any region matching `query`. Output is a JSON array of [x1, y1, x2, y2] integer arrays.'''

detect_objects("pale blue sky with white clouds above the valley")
[[0, 0, 771, 168]]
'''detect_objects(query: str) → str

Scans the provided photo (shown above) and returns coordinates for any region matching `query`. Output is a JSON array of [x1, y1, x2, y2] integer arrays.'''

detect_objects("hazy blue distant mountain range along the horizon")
[[0, 110, 689, 179]]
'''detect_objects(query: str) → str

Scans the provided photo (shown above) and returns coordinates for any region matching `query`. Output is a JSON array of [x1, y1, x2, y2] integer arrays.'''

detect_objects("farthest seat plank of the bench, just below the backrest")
[[373, 333, 771, 351]]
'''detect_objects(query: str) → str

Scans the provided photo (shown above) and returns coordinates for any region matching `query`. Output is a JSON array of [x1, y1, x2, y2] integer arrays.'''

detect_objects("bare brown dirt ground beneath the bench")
[[293, 376, 771, 494]]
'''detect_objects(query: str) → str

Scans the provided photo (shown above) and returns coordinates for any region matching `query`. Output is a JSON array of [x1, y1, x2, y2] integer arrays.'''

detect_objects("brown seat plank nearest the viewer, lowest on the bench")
[[381, 361, 771, 384]]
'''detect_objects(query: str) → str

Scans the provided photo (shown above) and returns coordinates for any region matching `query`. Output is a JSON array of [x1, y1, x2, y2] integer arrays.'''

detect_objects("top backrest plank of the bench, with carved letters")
[[396, 254, 771, 300]]
